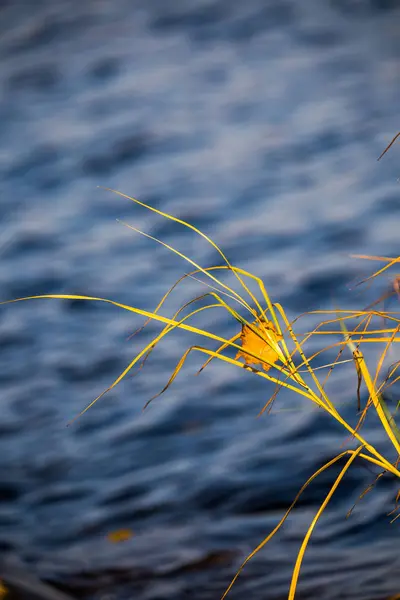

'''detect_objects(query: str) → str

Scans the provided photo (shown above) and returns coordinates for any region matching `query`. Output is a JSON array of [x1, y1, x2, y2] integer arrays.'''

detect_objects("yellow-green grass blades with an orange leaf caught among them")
[[3, 185, 400, 600]]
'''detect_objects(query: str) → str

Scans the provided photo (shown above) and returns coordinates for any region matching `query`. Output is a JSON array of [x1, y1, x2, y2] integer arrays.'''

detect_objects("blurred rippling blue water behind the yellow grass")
[[0, 0, 400, 600]]
